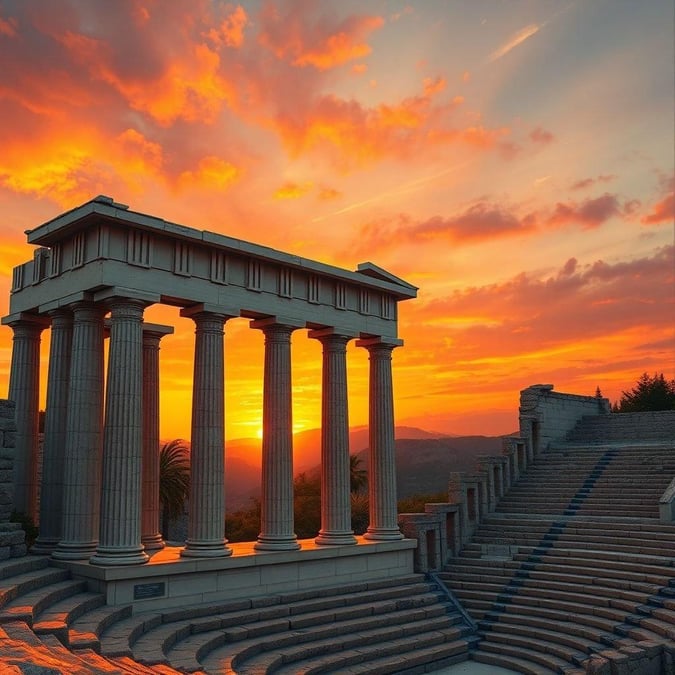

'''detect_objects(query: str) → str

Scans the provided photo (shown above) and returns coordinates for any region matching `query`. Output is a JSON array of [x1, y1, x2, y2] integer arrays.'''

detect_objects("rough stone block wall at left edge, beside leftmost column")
[[0, 399, 26, 560]]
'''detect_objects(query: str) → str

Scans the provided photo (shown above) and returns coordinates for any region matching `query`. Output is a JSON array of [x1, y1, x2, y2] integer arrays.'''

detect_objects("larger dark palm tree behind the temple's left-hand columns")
[[159, 438, 190, 537]]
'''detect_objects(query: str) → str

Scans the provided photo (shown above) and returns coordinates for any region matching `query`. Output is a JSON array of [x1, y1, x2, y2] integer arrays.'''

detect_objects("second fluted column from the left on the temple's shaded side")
[[31, 309, 73, 554]]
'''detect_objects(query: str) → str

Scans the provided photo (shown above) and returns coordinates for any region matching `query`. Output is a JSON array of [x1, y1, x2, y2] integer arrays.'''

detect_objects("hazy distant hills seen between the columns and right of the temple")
[[225, 427, 502, 510]]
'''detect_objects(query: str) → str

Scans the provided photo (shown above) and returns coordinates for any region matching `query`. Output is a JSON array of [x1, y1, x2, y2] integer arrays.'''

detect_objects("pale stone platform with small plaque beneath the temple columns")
[[52, 537, 417, 612]]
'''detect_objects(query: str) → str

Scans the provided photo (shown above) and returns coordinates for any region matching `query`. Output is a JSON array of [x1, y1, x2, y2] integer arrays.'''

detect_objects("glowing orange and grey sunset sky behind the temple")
[[0, 0, 675, 438]]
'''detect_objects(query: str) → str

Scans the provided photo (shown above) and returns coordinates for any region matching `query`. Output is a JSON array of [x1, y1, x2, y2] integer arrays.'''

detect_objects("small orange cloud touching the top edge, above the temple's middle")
[[258, 0, 384, 70]]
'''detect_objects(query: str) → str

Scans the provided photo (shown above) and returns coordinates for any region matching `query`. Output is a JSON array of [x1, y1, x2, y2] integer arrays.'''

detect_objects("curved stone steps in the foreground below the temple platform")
[[0, 556, 471, 675]]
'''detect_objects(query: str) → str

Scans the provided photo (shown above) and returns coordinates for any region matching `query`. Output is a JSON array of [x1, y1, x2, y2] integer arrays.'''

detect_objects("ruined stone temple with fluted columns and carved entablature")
[[2, 196, 416, 604]]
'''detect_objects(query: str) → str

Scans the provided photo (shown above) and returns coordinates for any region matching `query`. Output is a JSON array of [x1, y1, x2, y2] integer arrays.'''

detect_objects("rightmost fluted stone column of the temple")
[[356, 338, 403, 540]]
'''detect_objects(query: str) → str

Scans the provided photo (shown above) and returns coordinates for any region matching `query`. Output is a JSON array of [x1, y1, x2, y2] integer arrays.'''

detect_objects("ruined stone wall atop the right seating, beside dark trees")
[[519, 384, 610, 454]]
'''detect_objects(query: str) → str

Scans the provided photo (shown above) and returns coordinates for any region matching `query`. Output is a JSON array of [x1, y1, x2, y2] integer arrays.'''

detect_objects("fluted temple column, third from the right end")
[[251, 317, 300, 551]]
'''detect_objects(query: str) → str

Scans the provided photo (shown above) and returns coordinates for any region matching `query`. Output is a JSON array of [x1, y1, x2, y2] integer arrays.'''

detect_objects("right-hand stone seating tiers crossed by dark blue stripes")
[[439, 413, 675, 675]]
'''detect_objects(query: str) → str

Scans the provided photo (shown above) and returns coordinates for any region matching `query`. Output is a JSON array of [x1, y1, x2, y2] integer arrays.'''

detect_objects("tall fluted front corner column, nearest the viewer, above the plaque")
[[90, 298, 148, 565]]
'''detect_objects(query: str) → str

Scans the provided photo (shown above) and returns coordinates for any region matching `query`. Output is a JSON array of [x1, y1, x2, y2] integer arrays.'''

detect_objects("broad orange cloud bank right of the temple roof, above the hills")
[[406, 246, 675, 363]]
